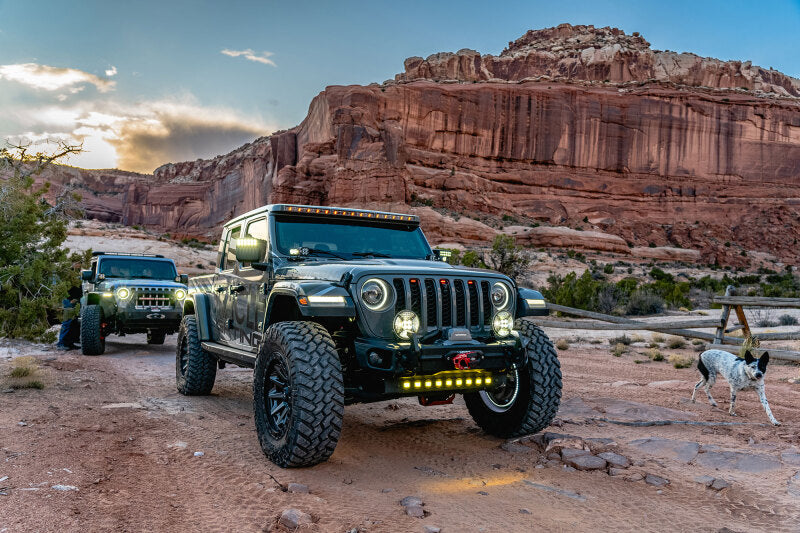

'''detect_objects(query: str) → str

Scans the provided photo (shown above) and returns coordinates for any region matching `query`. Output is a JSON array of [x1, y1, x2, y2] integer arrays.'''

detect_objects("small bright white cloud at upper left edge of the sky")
[[0, 63, 116, 94]]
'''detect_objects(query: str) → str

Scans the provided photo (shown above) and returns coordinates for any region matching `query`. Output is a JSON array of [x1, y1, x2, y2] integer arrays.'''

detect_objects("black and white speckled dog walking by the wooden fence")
[[692, 350, 781, 426]]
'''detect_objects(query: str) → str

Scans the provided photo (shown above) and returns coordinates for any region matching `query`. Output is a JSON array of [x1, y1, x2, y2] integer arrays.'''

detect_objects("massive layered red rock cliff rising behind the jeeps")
[[23, 25, 800, 265]]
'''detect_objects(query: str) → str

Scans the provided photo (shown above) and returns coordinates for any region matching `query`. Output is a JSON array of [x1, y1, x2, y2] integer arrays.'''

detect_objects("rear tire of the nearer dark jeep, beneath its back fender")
[[175, 315, 217, 396]]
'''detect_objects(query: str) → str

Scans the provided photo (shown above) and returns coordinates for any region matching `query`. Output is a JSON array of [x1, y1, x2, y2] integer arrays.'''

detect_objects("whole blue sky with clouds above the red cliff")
[[0, 0, 800, 171]]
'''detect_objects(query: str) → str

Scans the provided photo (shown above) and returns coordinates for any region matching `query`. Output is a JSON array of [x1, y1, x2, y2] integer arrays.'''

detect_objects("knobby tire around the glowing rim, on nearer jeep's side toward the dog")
[[464, 320, 561, 438]]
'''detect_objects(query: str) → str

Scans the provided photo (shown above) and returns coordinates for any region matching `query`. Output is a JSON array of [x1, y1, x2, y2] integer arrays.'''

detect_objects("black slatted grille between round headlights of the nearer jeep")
[[387, 276, 492, 331]]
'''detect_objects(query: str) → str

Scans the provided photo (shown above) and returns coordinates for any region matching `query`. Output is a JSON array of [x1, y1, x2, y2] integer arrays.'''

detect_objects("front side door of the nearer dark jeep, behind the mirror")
[[229, 213, 269, 349]]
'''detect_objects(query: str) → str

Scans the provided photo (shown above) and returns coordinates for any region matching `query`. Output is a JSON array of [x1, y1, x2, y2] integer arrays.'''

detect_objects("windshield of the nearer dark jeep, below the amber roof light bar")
[[275, 219, 431, 259]]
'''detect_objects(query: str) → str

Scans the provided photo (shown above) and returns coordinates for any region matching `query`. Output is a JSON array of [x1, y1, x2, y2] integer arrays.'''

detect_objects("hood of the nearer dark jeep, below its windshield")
[[275, 258, 509, 281]]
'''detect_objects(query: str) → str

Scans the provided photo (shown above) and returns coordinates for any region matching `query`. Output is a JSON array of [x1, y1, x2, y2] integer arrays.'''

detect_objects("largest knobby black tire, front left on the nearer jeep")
[[253, 322, 344, 468]]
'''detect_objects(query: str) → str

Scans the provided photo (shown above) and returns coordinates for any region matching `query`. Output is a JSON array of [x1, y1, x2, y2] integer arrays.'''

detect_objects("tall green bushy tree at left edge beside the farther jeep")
[[0, 141, 86, 342]]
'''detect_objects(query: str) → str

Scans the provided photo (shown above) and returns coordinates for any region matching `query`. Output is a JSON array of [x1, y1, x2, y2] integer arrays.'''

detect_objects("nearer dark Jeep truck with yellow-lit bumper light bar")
[[176, 205, 561, 467]]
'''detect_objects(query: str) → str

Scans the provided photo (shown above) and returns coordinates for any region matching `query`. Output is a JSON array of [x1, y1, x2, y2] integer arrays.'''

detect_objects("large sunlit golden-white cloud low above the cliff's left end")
[[13, 95, 277, 173]]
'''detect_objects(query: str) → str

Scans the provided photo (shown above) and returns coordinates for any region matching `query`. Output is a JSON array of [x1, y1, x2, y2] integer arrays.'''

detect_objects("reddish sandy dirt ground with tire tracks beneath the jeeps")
[[0, 335, 800, 533]]
